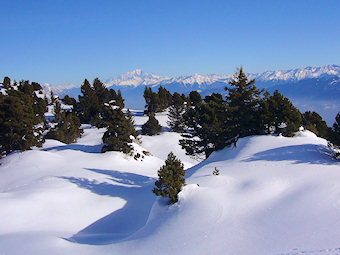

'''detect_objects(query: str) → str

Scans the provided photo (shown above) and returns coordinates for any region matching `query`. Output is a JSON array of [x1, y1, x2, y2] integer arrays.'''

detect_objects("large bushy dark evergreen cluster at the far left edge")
[[0, 78, 46, 155]]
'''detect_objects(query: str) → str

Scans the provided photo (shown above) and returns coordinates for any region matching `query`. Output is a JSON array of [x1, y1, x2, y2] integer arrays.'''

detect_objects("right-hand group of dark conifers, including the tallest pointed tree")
[[144, 67, 340, 157]]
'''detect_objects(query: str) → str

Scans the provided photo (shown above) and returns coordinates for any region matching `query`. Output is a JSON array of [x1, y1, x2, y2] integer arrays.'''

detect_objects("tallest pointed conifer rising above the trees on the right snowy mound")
[[225, 67, 263, 145]]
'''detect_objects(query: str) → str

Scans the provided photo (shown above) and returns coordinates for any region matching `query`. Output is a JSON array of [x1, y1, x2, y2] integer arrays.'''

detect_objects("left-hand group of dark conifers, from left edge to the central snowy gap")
[[0, 77, 139, 157]]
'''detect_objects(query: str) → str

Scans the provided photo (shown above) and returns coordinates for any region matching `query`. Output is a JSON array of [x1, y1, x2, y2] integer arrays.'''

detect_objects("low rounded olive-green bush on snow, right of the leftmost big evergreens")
[[45, 111, 83, 144]]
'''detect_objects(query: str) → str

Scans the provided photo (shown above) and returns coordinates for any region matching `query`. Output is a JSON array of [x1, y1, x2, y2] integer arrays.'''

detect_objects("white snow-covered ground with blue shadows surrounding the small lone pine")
[[0, 112, 340, 255]]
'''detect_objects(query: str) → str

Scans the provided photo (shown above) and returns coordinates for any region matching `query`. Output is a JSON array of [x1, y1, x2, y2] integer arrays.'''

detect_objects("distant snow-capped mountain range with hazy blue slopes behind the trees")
[[51, 65, 340, 124]]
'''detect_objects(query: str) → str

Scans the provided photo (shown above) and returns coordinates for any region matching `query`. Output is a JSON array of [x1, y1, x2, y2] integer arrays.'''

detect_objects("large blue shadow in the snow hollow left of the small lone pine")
[[60, 169, 156, 245]]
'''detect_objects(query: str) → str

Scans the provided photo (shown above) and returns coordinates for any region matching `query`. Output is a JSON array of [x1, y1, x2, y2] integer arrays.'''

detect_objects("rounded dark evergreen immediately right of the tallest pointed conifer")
[[261, 90, 302, 136]]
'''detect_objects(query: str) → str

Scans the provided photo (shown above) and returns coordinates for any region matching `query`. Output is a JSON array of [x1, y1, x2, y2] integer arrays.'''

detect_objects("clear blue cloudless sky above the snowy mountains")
[[0, 0, 340, 85]]
